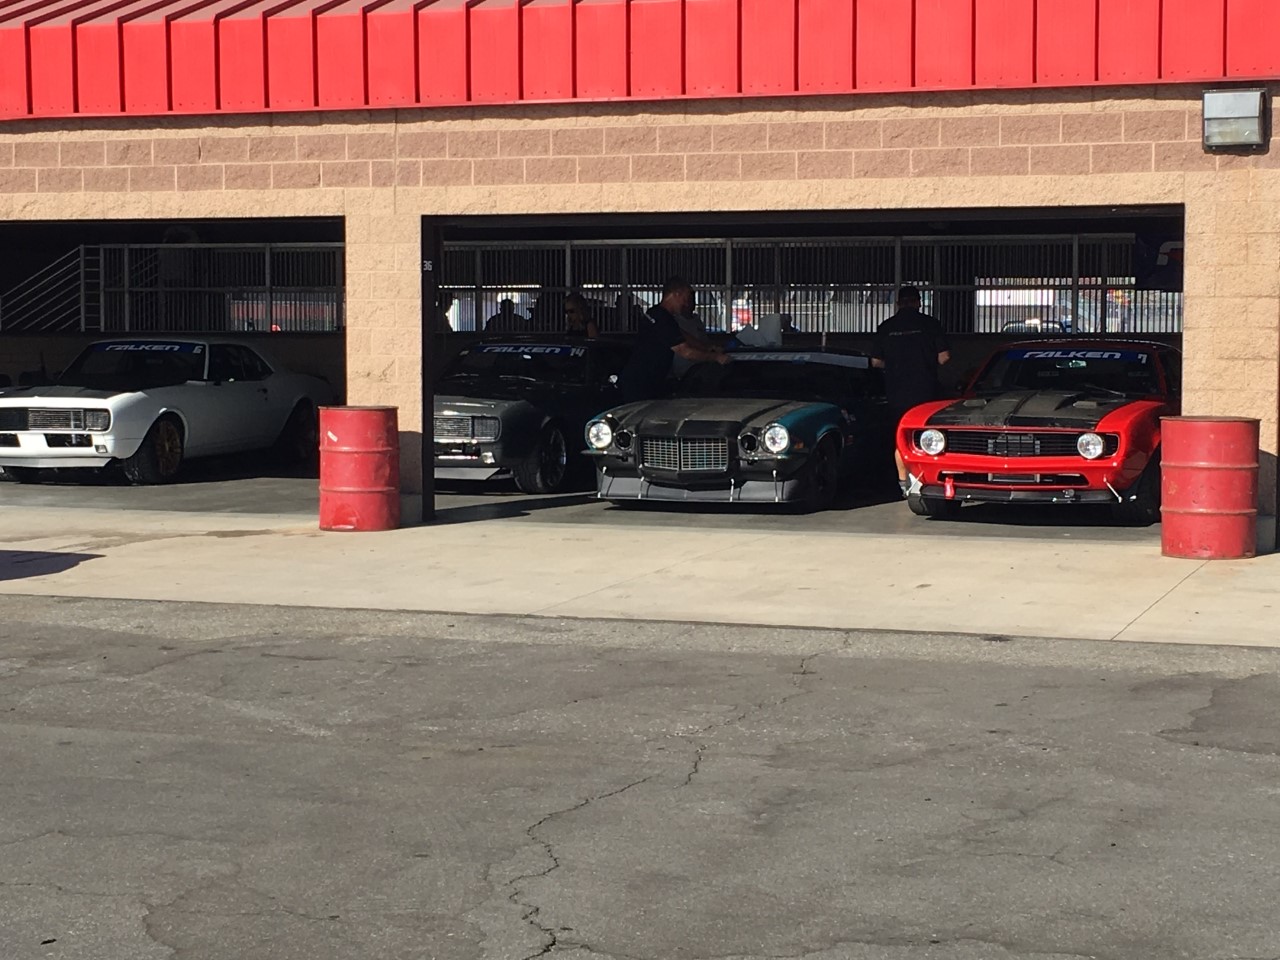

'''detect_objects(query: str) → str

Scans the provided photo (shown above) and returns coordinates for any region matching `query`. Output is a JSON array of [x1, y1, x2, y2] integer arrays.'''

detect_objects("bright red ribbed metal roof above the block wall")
[[0, 0, 1280, 119]]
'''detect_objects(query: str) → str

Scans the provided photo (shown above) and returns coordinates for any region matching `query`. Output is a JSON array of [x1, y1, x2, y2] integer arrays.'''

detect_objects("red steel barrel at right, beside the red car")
[[1160, 417, 1258, 559]]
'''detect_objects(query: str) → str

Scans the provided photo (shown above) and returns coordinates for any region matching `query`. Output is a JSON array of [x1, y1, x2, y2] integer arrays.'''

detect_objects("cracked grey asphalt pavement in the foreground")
[[0, 596, 1280, 960]]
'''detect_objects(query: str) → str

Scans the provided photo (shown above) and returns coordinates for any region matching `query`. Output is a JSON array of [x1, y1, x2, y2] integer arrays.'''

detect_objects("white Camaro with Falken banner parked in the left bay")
[[0, 337, 334, 484]]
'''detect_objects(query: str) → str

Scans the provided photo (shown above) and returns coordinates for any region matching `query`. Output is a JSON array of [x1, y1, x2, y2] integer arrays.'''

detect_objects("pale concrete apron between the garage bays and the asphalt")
[[0, 509, 1280, 646]]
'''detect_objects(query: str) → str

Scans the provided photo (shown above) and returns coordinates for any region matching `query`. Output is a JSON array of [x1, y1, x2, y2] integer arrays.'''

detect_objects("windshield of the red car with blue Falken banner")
[[974, 347, 1161, 397]]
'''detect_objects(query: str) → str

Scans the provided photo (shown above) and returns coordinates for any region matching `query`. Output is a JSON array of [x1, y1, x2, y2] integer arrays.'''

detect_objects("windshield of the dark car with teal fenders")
[[676, 353, 872, 402]]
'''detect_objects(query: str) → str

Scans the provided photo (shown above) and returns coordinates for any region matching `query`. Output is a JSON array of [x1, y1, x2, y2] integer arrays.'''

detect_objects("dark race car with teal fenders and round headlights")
[[586, 349, 892, 511]]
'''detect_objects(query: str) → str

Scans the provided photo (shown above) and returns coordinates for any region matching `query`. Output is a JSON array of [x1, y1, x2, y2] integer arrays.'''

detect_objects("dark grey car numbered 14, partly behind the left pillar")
[[434, 339, 628, 493]]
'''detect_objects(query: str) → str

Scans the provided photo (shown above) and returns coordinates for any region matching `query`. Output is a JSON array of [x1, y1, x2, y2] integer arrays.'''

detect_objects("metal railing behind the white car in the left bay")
[[0, 243, 346, 333]]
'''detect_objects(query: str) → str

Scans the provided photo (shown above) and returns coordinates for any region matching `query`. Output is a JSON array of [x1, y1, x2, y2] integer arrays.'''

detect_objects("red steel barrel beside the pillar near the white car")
[[320, 407, 399, 530]]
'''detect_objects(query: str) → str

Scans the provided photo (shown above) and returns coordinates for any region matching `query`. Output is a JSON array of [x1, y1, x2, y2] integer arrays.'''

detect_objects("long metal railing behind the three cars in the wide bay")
[[442, 233, 1183, 334]]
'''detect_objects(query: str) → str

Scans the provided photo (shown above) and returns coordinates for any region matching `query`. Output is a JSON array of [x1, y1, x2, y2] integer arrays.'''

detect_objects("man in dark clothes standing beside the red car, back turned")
[[872, 287, 951, 497]]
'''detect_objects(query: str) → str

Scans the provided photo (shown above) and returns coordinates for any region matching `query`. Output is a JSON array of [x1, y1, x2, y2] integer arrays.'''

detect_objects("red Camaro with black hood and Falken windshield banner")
[[897, 339, 1181, 524]]
